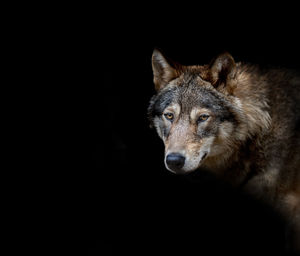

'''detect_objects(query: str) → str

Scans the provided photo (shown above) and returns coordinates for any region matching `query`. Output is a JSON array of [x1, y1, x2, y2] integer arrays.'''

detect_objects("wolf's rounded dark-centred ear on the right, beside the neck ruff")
[[210, 52, 235, 87]]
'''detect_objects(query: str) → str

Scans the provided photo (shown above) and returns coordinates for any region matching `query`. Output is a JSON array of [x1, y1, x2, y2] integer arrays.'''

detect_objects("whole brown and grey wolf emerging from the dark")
[[148, 49, 300, 252]]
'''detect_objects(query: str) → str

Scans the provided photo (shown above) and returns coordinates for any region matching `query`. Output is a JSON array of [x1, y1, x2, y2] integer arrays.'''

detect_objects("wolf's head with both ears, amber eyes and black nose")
[[149, 50, 244, 173]]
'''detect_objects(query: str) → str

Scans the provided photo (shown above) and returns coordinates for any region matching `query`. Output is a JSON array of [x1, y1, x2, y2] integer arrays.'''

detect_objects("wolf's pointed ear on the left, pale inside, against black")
[[152, 49, 180, 91]]
